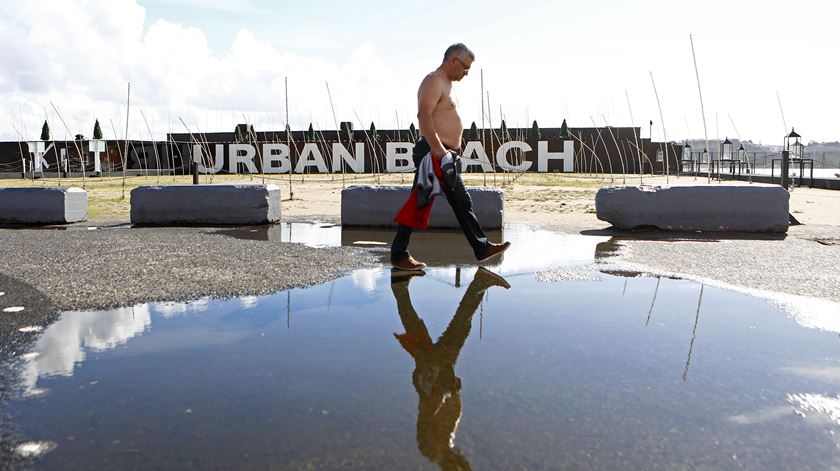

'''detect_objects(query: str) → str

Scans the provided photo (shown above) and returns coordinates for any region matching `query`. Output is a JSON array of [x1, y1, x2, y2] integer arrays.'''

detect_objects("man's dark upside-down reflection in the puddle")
[[391, 267, 510, 470]]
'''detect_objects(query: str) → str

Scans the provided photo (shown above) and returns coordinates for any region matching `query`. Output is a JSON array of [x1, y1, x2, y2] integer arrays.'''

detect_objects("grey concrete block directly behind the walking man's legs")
[[341, 185, 505, 229]]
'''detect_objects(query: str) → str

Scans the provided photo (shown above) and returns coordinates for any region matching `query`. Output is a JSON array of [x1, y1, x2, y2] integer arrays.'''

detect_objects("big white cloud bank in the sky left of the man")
[[0, 0, 406, 140]]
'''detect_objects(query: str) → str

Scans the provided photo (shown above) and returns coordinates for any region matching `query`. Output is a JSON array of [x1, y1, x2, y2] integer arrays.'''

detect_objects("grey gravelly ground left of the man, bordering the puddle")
[[0, 227, 377, 311]]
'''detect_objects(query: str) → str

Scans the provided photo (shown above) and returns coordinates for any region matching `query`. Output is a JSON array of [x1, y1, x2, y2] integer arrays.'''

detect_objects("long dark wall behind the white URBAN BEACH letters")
[[0, 127, 668, 174]]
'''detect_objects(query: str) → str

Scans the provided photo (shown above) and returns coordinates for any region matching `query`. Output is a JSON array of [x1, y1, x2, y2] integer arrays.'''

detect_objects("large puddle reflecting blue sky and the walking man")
[[5, 225, 840, 469]]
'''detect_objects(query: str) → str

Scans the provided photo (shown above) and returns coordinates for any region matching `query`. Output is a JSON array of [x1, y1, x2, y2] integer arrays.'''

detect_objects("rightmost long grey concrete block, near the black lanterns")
[[595, 183, 790, 232]]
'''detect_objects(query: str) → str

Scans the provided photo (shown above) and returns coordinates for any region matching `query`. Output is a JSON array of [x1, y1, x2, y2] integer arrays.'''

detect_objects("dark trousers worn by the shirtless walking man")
[[391, 137, 490, 261]]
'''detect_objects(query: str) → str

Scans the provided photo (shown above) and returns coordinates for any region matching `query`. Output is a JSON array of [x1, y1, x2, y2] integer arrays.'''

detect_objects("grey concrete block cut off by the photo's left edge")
[[0, 188, 87, 224]]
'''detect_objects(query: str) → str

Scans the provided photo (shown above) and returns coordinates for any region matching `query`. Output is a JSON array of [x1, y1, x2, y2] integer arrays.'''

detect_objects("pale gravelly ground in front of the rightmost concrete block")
[[584, 225, 840, 302]]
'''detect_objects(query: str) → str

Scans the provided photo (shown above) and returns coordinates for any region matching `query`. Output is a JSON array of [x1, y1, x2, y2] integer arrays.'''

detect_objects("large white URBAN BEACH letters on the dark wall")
[[192, 141, 574, 174]]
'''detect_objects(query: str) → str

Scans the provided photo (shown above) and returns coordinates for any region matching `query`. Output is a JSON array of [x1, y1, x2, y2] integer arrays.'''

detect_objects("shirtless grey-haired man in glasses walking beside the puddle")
[[391, 43, 510, 270]]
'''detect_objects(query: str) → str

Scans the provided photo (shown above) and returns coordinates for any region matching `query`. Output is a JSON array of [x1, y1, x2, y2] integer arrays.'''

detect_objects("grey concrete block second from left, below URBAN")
[[131, 184, 280, 226]]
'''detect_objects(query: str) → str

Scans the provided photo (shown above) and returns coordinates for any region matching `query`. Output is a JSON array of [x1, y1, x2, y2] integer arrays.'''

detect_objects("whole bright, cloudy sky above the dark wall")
[[0, 0, 840, 144]]
